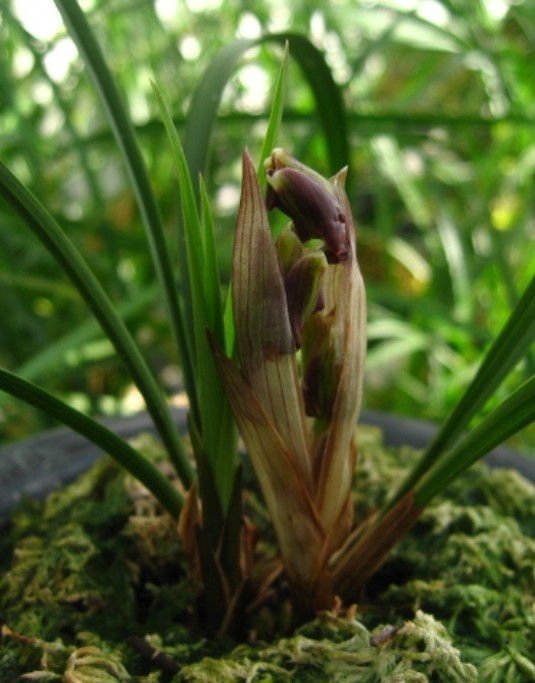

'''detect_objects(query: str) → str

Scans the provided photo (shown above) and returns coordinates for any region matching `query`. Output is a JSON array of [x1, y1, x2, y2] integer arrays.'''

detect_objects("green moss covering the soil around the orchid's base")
[[0, 429, 535, 683]]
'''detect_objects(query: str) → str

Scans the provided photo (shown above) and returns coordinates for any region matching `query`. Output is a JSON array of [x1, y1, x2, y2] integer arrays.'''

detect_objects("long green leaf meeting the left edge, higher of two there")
[[0, 162, 193, 487]]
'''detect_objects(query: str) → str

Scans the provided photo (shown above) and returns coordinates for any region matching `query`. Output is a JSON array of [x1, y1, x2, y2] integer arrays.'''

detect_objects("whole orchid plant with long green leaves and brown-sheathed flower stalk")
[[0, 0, 535, 633]]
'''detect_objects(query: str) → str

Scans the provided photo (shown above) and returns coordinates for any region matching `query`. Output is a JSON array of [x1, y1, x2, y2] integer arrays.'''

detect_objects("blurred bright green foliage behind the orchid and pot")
[[0, 0, 535, 451]]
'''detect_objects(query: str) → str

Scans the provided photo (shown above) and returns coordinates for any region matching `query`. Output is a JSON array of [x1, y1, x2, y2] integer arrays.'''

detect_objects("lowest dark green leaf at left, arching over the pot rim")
[[0, 368, 183, 518]]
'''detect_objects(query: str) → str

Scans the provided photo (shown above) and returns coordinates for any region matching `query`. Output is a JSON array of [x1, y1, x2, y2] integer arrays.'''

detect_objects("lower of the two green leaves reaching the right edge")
[[415, 375, 535, 506]]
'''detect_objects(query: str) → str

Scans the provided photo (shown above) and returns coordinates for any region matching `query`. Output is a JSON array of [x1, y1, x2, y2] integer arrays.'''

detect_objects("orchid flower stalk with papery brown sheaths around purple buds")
[[213, 149, 366, 613]]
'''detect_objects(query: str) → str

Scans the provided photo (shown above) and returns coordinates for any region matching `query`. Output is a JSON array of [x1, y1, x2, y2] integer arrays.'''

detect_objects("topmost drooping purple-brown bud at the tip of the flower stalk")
[[264, 148, 350, 263]]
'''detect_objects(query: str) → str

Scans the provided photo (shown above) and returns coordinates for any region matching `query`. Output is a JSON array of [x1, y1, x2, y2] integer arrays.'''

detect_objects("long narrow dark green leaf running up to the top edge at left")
[[50, 0, 188, 396]]
